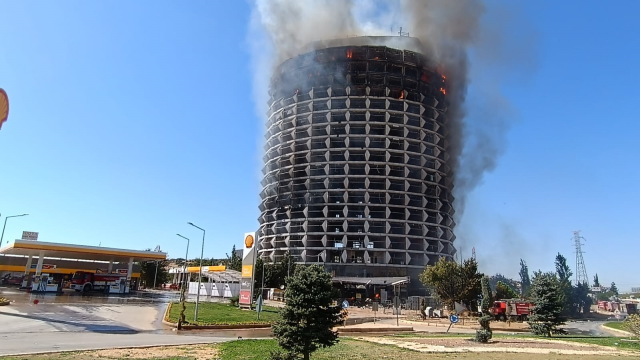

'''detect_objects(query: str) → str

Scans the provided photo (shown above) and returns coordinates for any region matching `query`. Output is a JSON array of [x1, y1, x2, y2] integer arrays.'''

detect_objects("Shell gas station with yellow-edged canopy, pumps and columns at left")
[[0, 240, 167, 293]]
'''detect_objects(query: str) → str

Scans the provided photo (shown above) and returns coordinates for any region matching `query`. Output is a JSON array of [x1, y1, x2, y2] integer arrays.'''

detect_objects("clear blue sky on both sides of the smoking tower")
[[0, 0, 640, 290]]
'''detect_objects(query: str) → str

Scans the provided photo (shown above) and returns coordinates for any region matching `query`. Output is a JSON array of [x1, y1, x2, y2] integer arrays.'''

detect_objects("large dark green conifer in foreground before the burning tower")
[[273, 265, 342, 360]]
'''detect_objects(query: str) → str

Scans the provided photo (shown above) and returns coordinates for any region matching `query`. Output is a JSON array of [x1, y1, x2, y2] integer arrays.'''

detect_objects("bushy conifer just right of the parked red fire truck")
[[529, 272, 566, 337]]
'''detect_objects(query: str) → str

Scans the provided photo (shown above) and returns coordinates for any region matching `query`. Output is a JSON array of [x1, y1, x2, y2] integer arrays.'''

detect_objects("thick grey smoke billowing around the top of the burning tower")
[[250, 0, 528, 225]]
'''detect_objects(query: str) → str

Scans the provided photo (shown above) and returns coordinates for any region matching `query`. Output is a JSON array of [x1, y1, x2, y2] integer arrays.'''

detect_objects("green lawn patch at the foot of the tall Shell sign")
[[168, 303, 280, 325]]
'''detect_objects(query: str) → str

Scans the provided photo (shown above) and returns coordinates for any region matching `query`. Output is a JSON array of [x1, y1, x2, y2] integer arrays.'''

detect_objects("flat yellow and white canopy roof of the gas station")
[[0, 240, 167, 262]]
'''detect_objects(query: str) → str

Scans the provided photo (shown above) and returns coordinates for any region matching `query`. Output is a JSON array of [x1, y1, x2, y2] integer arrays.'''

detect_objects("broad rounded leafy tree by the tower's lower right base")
[[419, 258, 483, 309]]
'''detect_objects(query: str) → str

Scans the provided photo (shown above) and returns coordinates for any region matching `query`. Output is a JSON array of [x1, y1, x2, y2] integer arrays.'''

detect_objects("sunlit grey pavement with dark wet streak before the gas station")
[[0, 288, 238, 356]]
